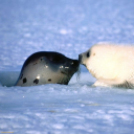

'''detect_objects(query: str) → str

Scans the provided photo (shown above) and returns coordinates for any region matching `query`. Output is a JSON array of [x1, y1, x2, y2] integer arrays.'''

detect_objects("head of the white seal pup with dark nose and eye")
[[79, 44, 110, 77]]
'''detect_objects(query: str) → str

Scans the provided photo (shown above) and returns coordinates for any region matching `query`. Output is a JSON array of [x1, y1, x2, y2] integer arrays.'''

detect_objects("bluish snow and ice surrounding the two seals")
[[0, 0, 134, 134]]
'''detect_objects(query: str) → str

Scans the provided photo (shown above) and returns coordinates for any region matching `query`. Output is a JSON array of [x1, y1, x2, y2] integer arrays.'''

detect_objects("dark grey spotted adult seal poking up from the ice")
[[15, 51, 79, 86]]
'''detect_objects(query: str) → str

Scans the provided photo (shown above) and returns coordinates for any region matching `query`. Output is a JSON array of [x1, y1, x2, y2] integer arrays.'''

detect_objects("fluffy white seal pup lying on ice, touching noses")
[[79, 43, 134, 88]]
